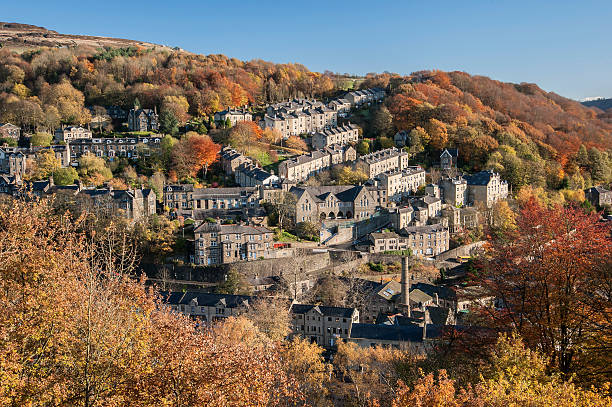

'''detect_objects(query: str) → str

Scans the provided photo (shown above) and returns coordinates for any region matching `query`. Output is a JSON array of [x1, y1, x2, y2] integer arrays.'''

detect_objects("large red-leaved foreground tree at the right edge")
[[479, 198, 612, 386]]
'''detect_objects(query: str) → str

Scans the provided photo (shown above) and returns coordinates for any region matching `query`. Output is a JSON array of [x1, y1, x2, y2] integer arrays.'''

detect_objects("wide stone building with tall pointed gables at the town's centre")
[[289, 185, 376, 223]]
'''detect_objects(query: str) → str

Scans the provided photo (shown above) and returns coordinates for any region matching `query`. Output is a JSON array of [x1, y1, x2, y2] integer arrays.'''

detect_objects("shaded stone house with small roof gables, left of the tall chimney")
[[290, 304, 359, 348]]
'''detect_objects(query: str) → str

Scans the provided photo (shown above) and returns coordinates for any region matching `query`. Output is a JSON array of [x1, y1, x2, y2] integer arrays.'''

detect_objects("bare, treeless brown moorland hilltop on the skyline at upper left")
[[0, 22, 169, 51]]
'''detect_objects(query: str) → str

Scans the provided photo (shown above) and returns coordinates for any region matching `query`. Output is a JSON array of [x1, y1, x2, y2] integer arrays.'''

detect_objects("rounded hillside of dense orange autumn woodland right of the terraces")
[[361, 71, 612, 189]]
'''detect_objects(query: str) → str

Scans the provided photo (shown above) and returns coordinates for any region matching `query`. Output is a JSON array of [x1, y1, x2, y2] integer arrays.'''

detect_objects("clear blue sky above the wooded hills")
[[0, 0, 612, 99]]
